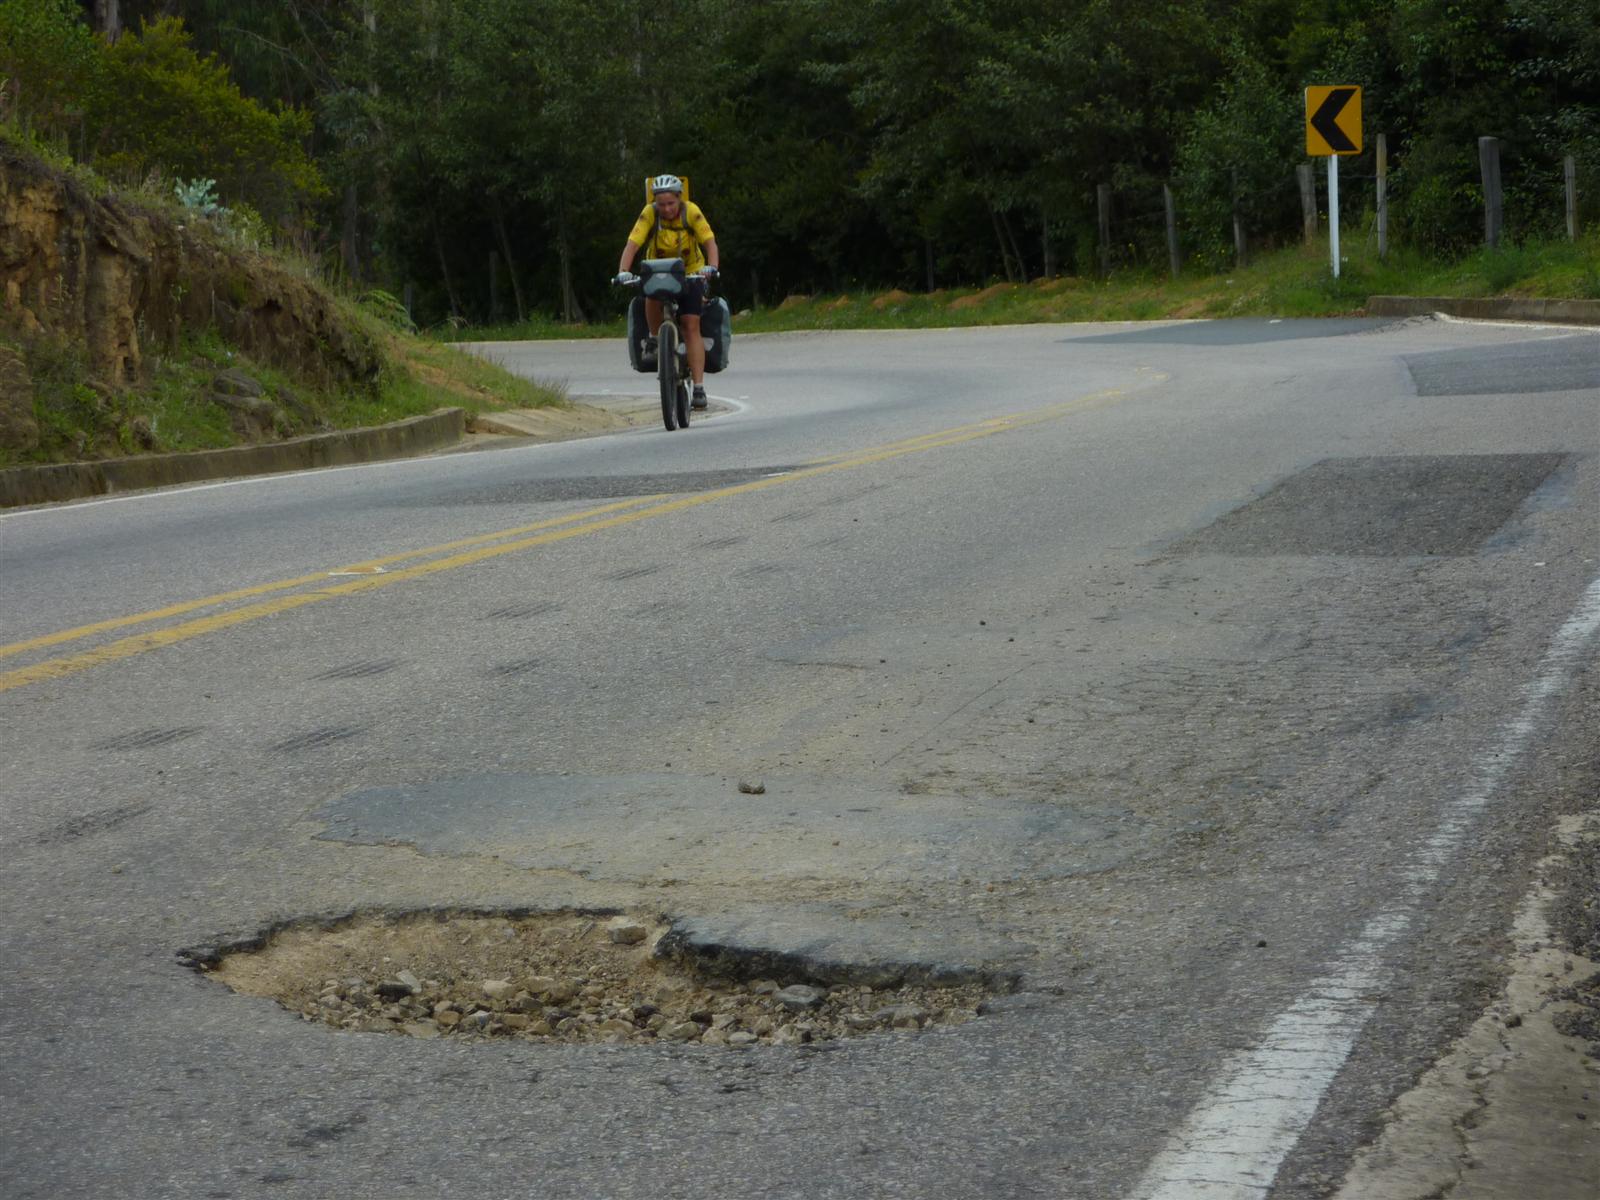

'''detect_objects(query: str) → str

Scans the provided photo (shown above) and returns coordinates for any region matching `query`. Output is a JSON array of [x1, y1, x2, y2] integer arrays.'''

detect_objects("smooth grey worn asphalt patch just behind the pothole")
[[312, 771, 1139, 883]]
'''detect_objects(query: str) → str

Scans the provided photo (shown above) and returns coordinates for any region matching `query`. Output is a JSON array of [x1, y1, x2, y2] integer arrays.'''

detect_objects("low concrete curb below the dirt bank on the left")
[[0, 408, 467, 509]]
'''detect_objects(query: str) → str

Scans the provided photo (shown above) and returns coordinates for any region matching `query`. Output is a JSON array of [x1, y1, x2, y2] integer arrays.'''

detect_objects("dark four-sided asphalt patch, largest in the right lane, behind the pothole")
[[1176, 454, 1566, 557]]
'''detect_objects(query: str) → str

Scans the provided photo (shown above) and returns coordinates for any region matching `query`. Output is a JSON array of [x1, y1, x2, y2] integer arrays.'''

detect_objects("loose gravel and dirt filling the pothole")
[[208, 914, 987, 1046]]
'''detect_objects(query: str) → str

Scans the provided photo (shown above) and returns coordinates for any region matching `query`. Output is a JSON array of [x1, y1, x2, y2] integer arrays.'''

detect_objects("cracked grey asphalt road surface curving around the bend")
[[0, 320, 1600, 1200]]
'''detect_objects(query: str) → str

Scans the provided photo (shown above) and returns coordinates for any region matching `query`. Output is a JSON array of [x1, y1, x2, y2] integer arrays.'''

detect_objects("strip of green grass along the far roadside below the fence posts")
[[438, 230, 1600, 341]]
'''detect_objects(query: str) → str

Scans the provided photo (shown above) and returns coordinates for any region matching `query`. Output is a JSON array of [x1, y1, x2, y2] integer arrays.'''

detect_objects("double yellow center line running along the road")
[[0, 389, 1123, 691]]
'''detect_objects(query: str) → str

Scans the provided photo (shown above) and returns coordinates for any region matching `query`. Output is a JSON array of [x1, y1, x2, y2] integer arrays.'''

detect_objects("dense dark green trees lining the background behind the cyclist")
[[15, 0, 1600, 322]]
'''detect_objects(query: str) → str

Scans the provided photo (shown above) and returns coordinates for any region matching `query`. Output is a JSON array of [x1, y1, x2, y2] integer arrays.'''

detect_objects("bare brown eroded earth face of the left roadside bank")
[[0, 142, 384, 450]]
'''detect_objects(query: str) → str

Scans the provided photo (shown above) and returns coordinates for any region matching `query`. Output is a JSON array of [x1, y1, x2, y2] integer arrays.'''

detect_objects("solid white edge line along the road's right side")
[[1133, 578, 1600, 1200]]
